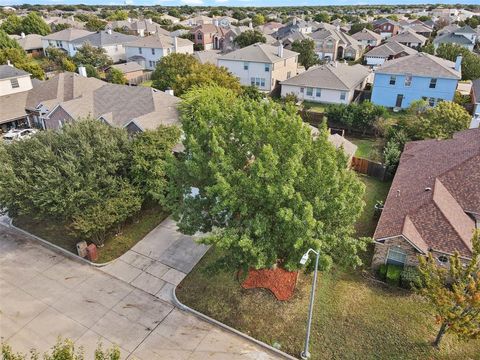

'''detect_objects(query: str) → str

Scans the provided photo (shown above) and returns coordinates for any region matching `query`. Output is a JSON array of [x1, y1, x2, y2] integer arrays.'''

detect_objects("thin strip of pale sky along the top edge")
[[0, 0, 480, 7]]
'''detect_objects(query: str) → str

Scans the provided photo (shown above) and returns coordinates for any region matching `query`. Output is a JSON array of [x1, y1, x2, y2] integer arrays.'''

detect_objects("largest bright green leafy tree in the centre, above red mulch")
[[172, 86, 365, 270]]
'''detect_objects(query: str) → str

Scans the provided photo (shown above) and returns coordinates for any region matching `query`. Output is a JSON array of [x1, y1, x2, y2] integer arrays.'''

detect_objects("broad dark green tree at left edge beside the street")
[[0, 119, 142, 244]]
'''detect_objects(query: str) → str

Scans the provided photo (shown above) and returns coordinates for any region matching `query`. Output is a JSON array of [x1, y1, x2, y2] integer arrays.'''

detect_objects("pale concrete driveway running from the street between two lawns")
[[101, 218, 208, 302]]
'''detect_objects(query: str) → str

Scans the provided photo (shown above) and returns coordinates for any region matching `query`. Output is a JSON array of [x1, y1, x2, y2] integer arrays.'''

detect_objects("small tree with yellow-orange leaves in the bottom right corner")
[[418, 231, 480, 347]]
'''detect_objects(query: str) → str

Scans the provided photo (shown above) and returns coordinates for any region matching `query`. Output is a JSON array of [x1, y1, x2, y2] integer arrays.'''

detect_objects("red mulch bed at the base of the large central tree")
[[242, 268, 298, 301]]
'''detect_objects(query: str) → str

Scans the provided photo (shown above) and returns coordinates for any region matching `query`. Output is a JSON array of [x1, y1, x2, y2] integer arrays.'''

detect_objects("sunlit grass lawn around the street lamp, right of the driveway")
[[177, 176, 480, 360]]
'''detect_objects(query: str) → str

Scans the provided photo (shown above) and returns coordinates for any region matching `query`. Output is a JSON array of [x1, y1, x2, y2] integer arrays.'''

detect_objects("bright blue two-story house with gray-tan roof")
[[371, 53, 462, 108]]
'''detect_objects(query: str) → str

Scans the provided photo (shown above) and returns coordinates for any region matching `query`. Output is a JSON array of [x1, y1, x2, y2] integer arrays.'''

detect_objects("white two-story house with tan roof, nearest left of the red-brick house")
[[124, 35, 193, 70]]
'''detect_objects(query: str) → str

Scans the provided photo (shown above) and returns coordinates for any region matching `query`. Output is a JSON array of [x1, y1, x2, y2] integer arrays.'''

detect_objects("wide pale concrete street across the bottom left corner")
[[0, 224, 275, 360]]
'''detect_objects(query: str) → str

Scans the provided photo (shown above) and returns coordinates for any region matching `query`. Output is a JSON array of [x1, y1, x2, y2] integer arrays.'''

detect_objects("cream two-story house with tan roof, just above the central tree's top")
[[218, 43, 298, 92]]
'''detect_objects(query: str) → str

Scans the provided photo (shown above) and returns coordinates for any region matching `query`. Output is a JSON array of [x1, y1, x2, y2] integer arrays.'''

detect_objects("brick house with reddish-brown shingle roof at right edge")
[[372, 129, 480, 268]]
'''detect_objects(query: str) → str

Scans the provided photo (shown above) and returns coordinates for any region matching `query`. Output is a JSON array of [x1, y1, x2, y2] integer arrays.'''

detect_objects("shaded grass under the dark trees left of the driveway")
[[13, 206, 168, 263]]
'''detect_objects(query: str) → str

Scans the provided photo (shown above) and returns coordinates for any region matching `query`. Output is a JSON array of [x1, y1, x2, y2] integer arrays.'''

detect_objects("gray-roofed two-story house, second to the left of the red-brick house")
[[72, 29, 138, 63]]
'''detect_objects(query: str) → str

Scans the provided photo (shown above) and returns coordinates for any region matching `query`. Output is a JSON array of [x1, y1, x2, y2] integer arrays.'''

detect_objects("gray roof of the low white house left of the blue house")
[[281, 63, 370, 90]]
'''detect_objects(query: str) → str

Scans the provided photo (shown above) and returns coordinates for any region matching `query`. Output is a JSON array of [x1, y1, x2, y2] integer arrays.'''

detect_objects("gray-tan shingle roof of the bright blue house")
[[377, 53, 462, 79]]
